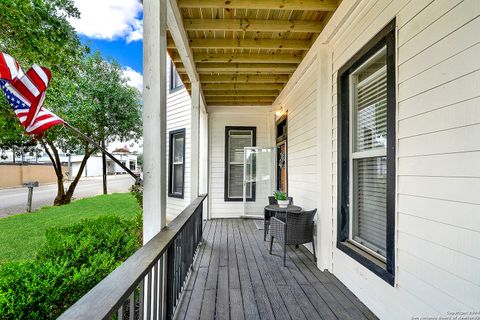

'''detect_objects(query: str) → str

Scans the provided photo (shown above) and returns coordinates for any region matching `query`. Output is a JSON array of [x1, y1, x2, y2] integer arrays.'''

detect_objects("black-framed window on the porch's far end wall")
[[224, 127, 256, 201]]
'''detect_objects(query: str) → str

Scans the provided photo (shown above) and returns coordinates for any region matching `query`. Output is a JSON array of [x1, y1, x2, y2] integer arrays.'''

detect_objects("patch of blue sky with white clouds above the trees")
[[69, 0, 143, 91]]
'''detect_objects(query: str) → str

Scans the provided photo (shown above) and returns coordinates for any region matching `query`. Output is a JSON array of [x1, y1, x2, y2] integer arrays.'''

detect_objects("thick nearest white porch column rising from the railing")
[[143, 0, 167, 243]]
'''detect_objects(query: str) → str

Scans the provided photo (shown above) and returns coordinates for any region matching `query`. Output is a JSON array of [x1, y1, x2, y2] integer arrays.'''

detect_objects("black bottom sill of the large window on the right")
[[337, 241, 395, 286]]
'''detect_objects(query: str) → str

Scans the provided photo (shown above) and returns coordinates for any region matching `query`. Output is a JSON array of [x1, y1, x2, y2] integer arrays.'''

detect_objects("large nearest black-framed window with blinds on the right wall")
[[337, 21, 396, 285]]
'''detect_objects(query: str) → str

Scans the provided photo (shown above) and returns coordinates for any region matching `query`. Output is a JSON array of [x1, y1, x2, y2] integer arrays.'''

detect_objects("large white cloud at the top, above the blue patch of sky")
[[70, 0, 143, 42]]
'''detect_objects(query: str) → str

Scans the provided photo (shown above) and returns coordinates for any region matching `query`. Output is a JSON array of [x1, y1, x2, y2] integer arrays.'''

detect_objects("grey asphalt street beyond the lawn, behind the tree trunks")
[[0, 175, 134, 218]]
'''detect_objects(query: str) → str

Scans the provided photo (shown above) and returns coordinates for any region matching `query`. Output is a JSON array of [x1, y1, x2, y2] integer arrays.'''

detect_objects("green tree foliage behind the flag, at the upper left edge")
[[0, 0, 86, 160]]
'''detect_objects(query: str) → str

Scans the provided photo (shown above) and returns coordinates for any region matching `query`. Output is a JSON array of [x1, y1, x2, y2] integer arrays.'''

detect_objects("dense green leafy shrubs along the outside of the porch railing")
[[0, 216, 141, 319]]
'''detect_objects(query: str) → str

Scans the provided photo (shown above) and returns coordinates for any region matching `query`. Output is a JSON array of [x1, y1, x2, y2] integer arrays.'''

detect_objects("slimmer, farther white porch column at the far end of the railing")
[[190, 81, 200, 201]]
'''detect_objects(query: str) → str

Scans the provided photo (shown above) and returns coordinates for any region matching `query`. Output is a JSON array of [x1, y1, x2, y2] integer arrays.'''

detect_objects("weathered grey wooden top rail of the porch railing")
[[58, 194, 207, 320]]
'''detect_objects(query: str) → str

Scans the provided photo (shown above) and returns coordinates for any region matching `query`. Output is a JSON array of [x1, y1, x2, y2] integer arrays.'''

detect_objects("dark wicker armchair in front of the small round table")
[[270, 209, 317, 266]]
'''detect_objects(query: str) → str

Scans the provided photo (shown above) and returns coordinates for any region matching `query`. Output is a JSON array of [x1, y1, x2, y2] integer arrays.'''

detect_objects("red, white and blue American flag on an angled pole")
[[0, 52, 65, 135]]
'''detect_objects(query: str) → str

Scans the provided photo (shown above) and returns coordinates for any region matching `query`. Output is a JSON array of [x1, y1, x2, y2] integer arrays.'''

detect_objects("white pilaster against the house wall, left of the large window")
[[316, 44, 336, 270]]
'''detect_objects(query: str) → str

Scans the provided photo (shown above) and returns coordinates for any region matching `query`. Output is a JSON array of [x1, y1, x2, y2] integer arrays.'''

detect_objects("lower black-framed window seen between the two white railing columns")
[[168, 129, 185, 198]]
